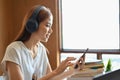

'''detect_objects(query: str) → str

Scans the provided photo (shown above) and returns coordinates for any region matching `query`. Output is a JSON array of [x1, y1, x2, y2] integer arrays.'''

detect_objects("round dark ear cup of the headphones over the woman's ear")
[[26, 19, 39, 33]]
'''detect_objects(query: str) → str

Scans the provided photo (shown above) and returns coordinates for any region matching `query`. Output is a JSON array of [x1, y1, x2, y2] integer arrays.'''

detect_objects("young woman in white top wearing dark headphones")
[[1, 6, 83, 80]]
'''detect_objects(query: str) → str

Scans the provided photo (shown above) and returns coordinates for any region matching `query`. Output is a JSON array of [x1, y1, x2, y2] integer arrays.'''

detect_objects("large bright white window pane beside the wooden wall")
[[60, 0, 120, 52]]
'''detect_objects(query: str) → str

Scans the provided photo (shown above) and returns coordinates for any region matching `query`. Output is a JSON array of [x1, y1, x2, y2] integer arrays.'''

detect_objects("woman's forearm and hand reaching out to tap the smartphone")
[[39, 57, 76, 80]]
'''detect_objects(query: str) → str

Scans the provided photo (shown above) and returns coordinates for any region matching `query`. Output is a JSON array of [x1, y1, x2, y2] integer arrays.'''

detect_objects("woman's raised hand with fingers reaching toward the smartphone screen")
[[55, 57, 76, 74]]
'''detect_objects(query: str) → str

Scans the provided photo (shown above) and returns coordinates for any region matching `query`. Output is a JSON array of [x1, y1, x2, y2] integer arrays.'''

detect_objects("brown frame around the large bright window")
[[59, 0, 120, 55]]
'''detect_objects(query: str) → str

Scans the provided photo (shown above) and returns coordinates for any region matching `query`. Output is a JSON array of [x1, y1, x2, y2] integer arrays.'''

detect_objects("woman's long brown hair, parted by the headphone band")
[[16, 6, 52, 42]]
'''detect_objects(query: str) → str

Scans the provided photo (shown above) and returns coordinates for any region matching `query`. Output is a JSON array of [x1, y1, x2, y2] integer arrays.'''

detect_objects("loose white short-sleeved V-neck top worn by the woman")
[[1, 41, 49, 80]]
